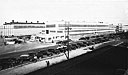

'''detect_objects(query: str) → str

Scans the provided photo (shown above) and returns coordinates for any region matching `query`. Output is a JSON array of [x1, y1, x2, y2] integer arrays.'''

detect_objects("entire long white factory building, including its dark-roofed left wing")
[[1, 20, 115, 42]]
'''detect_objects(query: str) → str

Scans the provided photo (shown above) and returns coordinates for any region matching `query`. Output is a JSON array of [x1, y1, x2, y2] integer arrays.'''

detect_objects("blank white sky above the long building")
[[0, 0, 128, 25]]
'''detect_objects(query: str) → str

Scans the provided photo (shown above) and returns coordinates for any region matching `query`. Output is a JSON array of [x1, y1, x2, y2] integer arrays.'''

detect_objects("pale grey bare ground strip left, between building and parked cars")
[[0, 42, 55, 55]]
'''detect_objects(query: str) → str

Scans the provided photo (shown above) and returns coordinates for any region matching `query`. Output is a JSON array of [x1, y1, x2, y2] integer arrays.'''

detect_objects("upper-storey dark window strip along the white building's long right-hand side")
[[59, 24, 108, 27]]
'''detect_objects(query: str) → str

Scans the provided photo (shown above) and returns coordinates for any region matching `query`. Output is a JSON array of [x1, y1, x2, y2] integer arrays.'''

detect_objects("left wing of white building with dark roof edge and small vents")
[[2, 20, 45, 36]]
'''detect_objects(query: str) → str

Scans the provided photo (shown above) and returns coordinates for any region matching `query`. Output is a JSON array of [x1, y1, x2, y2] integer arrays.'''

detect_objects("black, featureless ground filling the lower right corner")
[[27, 40, 128, 75]]
